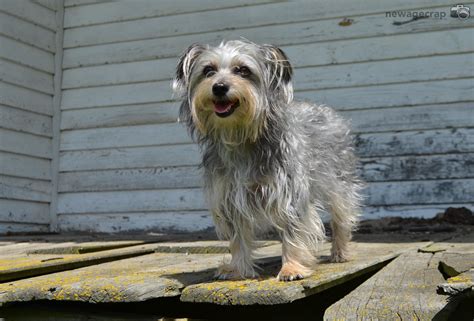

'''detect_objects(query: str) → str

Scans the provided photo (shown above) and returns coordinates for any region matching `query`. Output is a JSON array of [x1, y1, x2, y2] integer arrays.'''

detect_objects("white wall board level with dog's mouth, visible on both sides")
[[61, 102, 474, 133]]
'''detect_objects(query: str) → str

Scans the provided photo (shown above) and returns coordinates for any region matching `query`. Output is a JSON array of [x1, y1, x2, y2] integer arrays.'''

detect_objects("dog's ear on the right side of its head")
[[262, 45, 293, 102]]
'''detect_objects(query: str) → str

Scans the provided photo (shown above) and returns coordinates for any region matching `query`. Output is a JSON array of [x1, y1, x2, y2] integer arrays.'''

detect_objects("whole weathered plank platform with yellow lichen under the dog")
[[0, 233, 474, 320]]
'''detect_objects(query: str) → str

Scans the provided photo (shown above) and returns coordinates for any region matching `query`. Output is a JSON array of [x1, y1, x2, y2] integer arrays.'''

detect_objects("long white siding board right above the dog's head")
[[60, 14, 473, 67]]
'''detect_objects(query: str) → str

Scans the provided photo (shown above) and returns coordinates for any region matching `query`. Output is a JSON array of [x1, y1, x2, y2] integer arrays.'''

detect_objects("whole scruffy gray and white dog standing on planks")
[[173, 40, 361, 281]]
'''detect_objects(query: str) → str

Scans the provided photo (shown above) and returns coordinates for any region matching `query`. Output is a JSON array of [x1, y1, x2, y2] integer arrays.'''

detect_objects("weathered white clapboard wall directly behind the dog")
[[0, 0, 474, 232]]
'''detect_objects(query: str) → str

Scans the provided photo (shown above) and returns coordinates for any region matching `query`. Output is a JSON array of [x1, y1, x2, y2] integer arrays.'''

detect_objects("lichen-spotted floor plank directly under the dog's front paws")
[[180, 243, 428, 305]]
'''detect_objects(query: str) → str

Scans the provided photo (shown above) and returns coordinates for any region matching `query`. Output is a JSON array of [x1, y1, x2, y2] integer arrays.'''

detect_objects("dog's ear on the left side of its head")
[[173, 43, 206, 96]]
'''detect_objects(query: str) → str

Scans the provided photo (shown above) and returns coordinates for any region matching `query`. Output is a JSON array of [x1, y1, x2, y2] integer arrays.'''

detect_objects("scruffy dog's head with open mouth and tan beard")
[[173, 40, 293, 144]]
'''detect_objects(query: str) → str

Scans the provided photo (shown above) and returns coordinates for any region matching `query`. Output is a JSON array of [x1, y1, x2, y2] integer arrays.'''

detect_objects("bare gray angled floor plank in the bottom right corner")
[[324, 239, 473, 320]]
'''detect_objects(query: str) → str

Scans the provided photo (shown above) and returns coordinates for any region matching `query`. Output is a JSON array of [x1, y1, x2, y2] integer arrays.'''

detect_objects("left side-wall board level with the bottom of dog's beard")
[[0, 128, 52, 159]]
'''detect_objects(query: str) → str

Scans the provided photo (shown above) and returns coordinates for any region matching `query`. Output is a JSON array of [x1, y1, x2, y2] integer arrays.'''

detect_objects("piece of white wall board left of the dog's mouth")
[[59, 102, 179, 129]]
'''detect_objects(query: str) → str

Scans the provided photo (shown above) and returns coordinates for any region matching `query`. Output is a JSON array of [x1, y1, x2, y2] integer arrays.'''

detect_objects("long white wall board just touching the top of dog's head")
[[64, 15, 472, 68]]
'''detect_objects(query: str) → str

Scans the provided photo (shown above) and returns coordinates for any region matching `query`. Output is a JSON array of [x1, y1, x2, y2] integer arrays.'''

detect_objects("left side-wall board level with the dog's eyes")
[[0, 59, 53, 94]]
